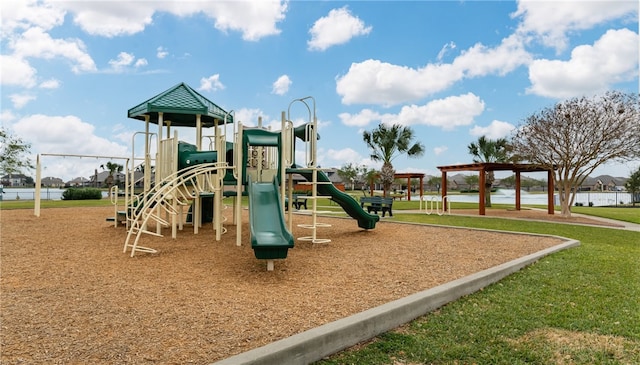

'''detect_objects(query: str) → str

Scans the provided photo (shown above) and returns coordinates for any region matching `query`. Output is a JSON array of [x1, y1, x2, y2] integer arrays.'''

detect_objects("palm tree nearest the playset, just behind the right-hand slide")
[[362, 123, 424, 197]]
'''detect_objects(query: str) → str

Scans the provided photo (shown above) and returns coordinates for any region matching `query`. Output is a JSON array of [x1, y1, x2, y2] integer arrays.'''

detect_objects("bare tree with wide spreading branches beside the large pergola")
[[511, 91, 640, 217]]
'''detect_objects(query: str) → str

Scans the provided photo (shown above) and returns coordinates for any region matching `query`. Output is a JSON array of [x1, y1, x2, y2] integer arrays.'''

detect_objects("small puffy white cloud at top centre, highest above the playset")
[[307, 6, 373, 51]]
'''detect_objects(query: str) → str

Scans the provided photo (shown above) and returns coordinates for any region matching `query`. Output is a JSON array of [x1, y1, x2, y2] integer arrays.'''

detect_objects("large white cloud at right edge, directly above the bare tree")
[[527, 29, 640, 98]]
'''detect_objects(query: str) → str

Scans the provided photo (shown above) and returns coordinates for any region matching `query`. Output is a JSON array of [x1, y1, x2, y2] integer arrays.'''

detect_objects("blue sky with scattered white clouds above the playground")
[[0, 0, 640, 180]]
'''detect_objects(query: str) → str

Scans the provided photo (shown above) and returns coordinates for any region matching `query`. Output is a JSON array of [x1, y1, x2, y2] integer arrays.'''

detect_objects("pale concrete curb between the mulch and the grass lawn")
[[214, 238, 580, 365]]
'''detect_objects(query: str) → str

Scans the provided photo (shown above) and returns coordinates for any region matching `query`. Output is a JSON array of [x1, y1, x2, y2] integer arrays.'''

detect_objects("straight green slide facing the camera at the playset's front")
[[248, 179, 294, 260]]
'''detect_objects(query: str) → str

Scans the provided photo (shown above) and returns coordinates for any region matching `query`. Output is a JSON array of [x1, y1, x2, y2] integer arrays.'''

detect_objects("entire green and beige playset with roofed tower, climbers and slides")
[[102, 83, 379, 270]]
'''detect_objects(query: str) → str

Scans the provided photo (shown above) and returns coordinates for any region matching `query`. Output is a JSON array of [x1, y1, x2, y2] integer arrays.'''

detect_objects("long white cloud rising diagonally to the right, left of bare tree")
[[336, 36, 531, 106]]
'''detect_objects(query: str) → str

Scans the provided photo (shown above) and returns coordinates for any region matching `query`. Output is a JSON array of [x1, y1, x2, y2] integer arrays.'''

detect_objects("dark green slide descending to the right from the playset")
[[287, 168, 380, 229]]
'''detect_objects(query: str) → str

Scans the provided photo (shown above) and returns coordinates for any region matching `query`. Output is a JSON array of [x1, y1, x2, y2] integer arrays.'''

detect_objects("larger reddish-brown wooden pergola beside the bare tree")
[[438, 162, 554, 215]]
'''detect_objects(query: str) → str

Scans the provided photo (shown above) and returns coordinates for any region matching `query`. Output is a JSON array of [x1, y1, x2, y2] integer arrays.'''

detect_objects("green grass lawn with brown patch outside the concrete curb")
[[318, 212, 640, 365]]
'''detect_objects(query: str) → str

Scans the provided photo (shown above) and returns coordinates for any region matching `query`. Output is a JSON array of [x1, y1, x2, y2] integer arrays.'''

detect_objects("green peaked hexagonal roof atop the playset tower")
[[127, 82, 233, 128]]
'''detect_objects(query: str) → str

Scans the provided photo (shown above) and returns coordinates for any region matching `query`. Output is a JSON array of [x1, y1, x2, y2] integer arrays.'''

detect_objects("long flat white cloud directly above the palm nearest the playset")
[[338, 93, 484, 130]]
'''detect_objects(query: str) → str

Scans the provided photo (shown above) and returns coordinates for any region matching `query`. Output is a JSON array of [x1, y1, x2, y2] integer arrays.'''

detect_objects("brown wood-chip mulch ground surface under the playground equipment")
[[0, 207, 559, 364]]
